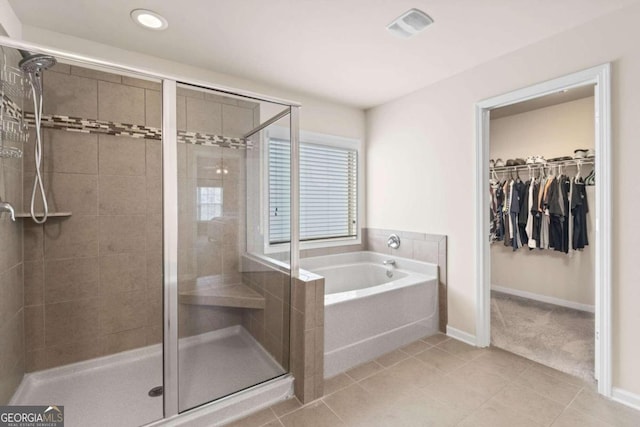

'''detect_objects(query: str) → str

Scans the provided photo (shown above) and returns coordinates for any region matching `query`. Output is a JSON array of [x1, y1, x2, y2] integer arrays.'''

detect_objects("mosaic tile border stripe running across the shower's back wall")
[[25, 112, 253, 149]]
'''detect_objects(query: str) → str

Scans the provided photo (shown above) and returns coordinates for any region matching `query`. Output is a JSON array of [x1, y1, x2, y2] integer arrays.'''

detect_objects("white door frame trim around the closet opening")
[[475, 63, 612, 397]]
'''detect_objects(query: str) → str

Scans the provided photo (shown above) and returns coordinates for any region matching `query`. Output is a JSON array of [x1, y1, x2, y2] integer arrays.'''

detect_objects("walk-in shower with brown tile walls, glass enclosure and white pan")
[[0, 39, 297, 427]]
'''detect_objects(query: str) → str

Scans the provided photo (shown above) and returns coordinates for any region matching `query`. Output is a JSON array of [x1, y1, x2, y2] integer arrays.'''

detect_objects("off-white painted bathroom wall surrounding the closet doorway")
[[367, 1, 640, 394]]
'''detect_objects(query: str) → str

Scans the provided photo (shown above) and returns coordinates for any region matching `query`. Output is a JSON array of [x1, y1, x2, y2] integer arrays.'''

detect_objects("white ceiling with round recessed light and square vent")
[[9, 0, 638, 108]]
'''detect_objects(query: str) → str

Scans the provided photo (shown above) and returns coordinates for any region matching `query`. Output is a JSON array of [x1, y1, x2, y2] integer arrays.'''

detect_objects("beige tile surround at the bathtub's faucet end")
[[365, 228, 447, 333]]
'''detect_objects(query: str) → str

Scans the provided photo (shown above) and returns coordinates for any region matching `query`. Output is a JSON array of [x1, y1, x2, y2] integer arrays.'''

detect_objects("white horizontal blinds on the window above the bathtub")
[[269, 138, 358, 244]]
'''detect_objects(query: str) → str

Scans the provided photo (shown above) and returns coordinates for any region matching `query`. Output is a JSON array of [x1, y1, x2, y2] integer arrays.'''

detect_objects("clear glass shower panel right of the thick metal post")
[[176, 85, 290, 412]]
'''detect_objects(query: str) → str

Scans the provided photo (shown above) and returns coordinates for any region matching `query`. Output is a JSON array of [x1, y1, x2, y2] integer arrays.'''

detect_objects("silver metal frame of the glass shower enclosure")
[[0, 36, 301, 425]]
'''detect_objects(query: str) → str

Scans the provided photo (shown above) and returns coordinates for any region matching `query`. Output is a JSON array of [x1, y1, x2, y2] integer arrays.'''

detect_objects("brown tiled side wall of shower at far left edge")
[[0, 47, 24, 405]]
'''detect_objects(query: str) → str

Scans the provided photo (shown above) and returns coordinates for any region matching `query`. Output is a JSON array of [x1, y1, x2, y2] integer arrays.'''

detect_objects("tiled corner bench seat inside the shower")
[[178, 283, 265, 309]]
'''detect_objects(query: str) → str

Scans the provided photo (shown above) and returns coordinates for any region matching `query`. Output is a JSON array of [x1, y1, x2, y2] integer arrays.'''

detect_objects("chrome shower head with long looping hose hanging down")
[[18, 50, 56, 224]]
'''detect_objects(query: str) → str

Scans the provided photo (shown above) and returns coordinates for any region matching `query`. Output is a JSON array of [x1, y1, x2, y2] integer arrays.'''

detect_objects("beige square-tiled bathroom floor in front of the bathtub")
[[222, 335, 640, 427]]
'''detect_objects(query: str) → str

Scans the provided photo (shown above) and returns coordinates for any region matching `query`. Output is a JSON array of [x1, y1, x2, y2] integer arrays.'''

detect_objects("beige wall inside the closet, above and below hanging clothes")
[[490, 96, 595, 306]]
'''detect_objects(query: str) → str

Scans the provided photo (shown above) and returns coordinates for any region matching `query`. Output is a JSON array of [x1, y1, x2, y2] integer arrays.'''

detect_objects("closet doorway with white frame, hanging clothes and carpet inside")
[[476, 64, 611, 396]]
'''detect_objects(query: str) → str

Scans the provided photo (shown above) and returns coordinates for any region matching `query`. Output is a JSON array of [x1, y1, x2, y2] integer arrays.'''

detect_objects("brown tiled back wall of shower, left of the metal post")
[[23, 64, 162, 371]]
